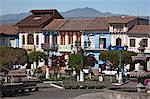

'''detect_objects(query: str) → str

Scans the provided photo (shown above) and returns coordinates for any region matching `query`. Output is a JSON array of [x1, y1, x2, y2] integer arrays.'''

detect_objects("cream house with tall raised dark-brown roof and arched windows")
[[16, 9, 63, 52]]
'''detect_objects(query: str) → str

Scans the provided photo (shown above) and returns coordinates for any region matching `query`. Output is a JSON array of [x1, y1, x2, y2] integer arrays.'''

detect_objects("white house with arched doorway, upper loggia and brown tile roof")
[[109, 16, 148, 46]]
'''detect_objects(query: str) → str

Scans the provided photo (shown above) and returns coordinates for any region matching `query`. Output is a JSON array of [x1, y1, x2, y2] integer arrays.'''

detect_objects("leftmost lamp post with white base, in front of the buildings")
[[41, 43, 57, 79]]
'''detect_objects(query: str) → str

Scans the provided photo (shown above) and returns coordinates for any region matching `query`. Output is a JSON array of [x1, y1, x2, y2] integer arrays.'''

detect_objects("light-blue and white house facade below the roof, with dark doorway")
[[84, 31, 110, 68]]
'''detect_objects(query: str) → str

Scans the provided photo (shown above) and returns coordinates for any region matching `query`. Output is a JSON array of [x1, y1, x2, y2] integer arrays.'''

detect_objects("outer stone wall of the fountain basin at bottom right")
[[104, 89, 150, 99]]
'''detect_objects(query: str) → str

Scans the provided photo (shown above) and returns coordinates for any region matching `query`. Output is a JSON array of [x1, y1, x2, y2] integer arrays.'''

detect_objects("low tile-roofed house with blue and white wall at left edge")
[[0, 24, 19, 47]]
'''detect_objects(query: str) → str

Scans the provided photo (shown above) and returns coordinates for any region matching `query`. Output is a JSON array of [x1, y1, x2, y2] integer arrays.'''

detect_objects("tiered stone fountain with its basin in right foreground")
[[104, 40, 150, 99]]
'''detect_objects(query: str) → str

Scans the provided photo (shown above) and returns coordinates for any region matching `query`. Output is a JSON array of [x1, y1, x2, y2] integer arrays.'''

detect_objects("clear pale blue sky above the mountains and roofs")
[[0, 0, 150, 16]]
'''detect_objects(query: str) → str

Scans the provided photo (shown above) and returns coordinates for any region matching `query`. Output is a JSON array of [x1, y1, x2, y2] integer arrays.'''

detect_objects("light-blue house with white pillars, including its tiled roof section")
[[84, 17, 111, 68]]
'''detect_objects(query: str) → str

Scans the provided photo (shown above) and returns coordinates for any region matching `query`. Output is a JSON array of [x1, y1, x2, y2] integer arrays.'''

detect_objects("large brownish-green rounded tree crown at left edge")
[[0, 46, 27, 69]]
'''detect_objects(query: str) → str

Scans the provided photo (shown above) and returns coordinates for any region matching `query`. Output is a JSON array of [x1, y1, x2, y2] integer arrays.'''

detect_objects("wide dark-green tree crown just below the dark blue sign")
[[100, 50, 136, 68]]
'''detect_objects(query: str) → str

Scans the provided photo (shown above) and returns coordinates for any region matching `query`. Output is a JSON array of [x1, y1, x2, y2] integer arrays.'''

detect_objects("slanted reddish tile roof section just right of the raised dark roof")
[[42, 19, 68, 31]]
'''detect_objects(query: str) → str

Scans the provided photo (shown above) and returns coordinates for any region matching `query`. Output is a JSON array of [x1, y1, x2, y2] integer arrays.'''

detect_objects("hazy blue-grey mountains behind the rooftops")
[[0, 7, 129, 24]]
